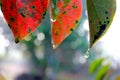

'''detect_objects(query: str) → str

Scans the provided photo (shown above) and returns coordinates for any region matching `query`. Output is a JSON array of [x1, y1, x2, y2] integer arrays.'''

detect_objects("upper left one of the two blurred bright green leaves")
[[89, 58, 104, 74]]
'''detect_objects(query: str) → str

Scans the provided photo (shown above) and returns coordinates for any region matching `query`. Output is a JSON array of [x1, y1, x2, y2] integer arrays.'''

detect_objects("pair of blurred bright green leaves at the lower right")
[[89, 58, 110, 80]]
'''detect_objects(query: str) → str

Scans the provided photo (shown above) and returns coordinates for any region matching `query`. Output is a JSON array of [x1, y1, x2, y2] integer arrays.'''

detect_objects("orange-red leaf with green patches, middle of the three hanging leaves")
[[50, 0, 82, 48]]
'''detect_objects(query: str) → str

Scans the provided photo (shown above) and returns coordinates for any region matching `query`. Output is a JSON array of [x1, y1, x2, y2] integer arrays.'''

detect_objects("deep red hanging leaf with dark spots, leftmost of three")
[[1, 0, 48, 43]]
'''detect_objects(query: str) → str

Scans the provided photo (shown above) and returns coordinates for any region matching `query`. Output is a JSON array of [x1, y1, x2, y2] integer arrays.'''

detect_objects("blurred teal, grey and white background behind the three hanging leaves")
[[0, 0, 120, 80]]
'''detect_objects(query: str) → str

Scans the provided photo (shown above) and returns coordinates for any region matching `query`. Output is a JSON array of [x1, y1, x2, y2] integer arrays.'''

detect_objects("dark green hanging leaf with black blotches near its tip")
[[87, 0, 116, 47]]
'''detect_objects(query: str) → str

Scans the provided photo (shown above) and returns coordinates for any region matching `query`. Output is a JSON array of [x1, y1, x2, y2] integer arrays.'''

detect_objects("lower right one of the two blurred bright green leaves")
[[95, 64, 110, 80]]
